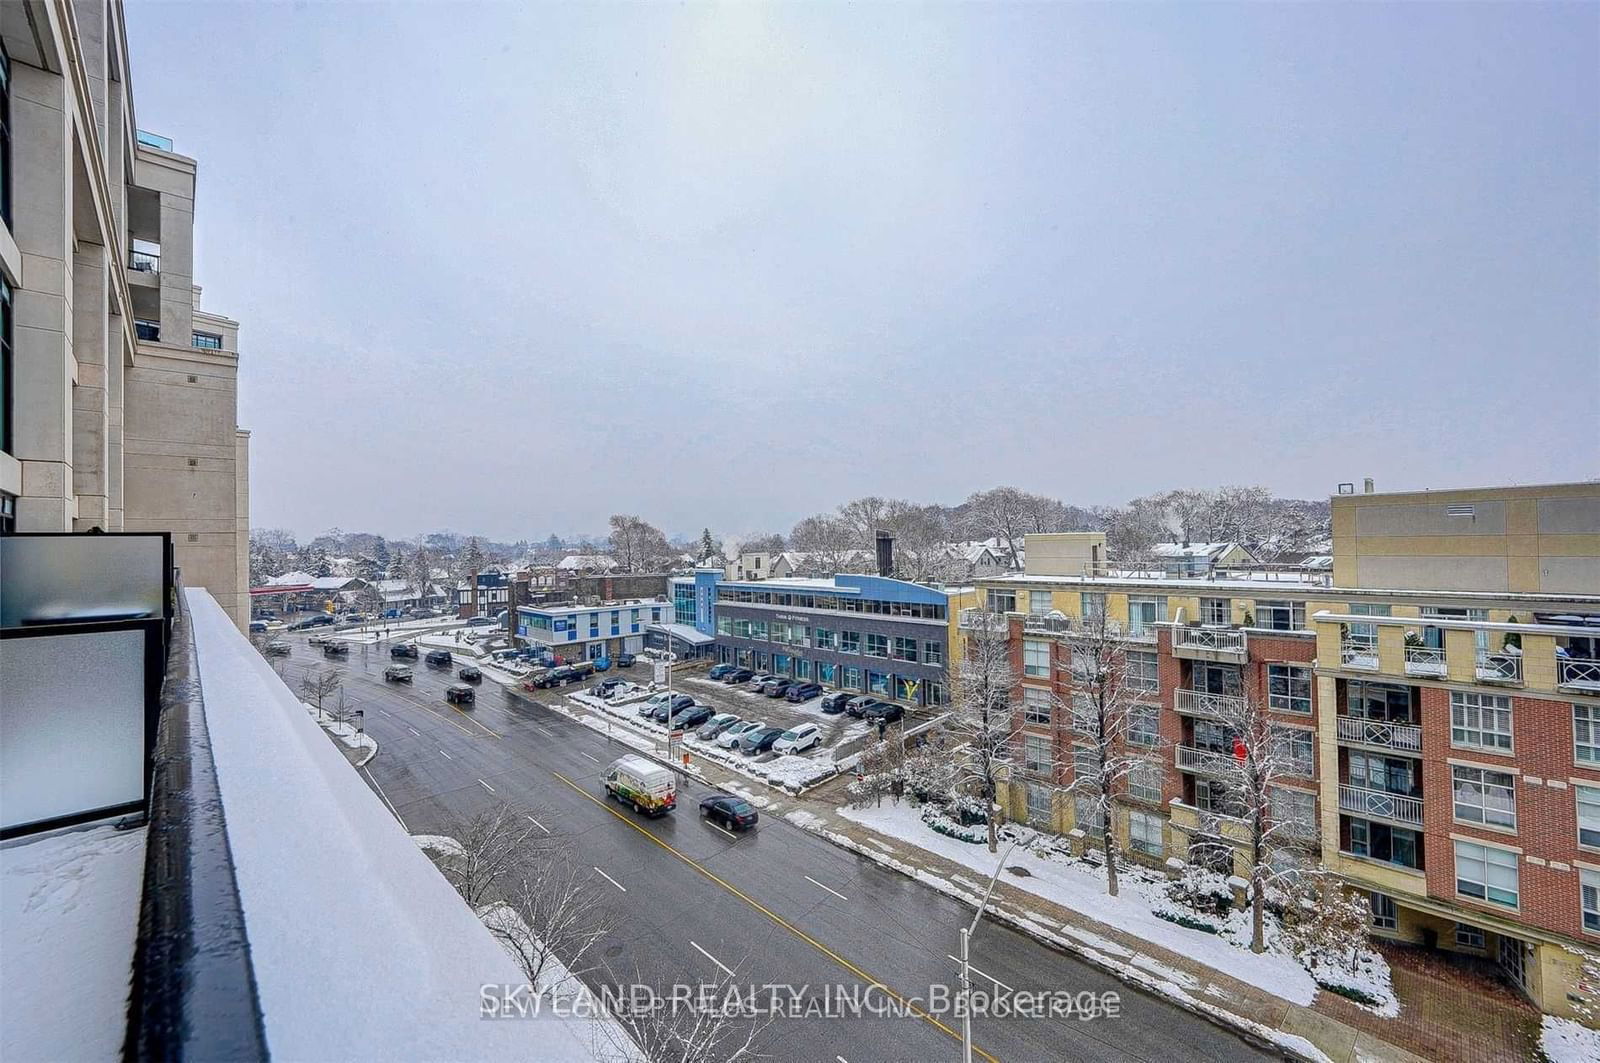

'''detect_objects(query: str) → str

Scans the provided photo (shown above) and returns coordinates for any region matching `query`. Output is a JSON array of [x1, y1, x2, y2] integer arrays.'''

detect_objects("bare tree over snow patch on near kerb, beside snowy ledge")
[[482, 836, 619, 993]]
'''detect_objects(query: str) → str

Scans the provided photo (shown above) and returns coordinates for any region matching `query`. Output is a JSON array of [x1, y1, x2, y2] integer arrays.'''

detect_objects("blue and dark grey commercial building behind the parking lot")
[[672, 568, 973, 706]]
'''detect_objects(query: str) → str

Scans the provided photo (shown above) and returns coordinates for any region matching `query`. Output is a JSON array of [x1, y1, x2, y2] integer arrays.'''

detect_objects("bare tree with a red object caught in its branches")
[[1206, 684, 1317, 953]]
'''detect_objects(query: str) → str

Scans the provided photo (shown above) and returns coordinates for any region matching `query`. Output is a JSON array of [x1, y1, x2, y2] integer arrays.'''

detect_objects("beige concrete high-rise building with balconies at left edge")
[[0, 0, 250, 624]]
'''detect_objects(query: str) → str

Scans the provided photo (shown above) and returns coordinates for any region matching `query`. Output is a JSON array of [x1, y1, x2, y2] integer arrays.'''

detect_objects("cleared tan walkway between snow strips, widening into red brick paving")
[[773, 780, 1539, 1063]]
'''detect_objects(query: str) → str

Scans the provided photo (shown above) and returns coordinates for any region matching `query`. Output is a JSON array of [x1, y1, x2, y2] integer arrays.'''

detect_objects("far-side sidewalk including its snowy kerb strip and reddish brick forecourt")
[[773, 771, 1539, 1063]]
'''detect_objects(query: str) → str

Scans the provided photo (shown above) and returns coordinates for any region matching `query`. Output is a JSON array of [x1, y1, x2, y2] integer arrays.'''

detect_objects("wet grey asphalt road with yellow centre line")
[[283, 636, 1270, 1063]]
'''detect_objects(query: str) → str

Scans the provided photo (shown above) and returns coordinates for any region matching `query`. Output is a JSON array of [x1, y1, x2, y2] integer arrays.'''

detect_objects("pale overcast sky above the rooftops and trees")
[[128, 2, 1600, 538]]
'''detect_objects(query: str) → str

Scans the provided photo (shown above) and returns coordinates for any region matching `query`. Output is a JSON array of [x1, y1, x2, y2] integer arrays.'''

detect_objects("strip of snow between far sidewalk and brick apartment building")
[[840, 804, 1317, 1004]]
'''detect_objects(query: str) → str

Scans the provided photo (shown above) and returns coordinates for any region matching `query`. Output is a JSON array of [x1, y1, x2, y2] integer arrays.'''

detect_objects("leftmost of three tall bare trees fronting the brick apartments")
[[949, 613, 1019, 852]]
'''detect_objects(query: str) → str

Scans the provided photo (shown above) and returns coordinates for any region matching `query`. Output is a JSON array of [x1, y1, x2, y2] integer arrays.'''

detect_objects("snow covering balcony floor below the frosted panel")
[[0, 826, 144, 1060]]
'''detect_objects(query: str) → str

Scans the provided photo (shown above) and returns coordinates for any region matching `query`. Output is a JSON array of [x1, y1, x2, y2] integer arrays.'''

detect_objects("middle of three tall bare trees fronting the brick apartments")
[[1069, 612, 1160, 897]]
